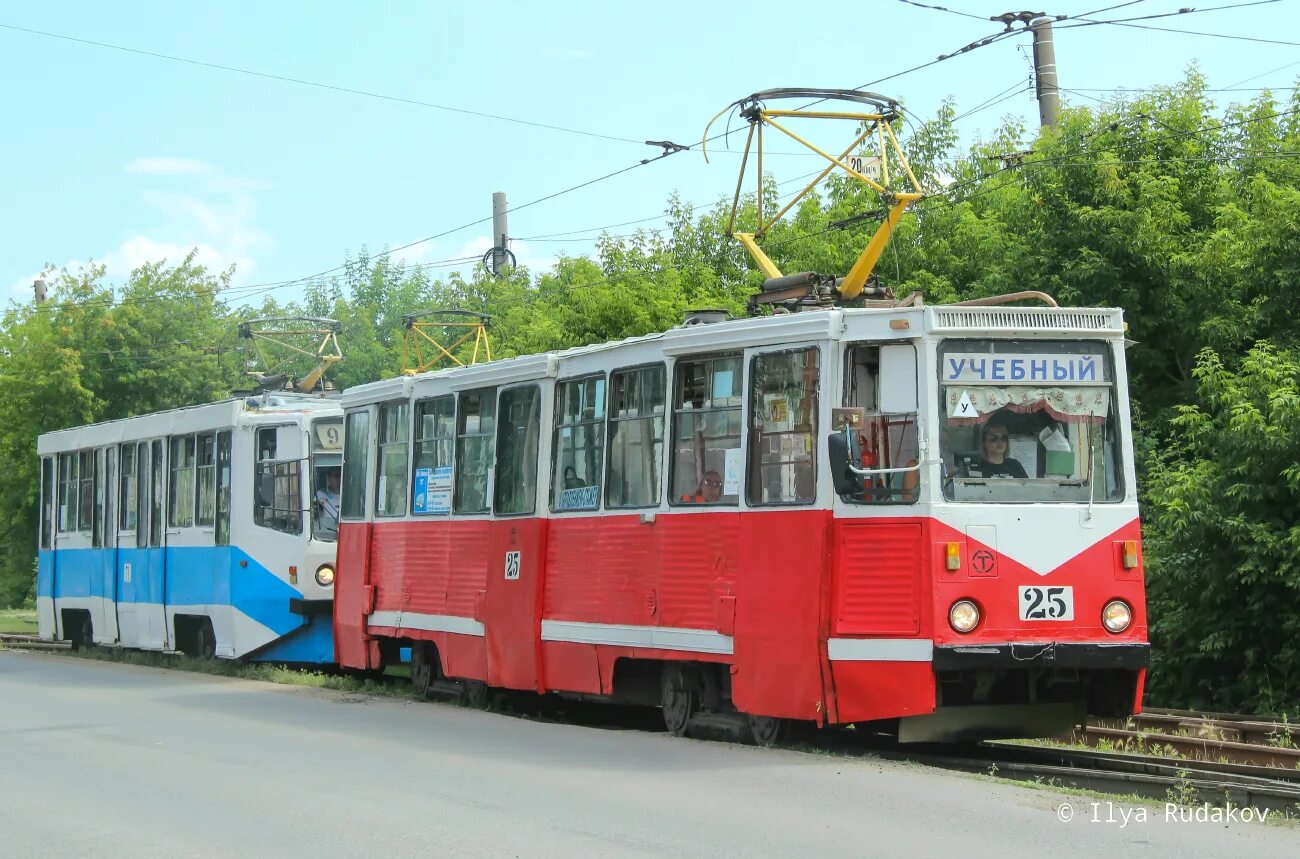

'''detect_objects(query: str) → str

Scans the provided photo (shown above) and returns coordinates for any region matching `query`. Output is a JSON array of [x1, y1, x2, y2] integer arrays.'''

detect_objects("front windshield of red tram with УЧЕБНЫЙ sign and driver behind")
[[939, 340, 1123, 502]]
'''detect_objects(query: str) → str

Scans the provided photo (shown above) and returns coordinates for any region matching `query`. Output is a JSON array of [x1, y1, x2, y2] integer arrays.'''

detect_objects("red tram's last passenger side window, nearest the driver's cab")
[[748, 348, 820, 504]]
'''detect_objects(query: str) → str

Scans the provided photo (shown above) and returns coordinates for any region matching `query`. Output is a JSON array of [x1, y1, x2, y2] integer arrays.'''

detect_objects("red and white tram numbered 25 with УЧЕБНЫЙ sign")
[[334, 305, 1148, 743]]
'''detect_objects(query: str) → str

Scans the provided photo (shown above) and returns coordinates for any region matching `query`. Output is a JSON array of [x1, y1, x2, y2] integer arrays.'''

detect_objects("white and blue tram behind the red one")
[[36, 394, 343, 663]]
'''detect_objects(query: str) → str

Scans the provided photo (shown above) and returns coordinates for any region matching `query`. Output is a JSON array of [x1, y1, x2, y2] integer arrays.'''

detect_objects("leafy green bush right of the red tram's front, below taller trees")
[[1147, 343, 1300, 712]]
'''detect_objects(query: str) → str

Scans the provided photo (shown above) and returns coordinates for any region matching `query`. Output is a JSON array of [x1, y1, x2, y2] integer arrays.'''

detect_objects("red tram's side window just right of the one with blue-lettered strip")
[[605, 365, 667, 507]]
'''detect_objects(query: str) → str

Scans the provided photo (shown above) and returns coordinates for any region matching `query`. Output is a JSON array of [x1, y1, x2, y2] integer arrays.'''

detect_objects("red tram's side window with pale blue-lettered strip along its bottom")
[[551, 376, 605, 511]]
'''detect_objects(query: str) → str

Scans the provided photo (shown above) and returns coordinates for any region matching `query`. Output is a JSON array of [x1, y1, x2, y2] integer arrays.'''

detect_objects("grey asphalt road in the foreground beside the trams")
[[0, 651, 1300, 859]]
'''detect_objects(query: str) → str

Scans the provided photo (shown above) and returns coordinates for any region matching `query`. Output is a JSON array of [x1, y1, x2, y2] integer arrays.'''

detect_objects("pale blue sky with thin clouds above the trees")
[[0, 0, 1300, 300]]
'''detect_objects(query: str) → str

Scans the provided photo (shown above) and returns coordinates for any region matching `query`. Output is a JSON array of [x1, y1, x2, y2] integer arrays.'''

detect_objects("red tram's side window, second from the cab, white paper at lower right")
[[668, 356, 745, 504]]
